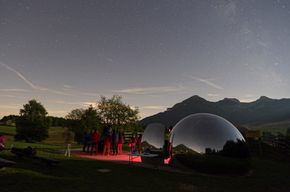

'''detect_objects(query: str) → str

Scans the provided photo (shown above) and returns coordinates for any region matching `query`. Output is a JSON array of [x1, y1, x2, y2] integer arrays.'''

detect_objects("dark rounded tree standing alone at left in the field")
[[15, 99, 51, 142]]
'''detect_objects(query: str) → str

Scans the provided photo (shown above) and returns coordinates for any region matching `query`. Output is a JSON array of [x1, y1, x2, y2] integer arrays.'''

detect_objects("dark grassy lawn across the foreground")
[[0, 124, 290, 192]]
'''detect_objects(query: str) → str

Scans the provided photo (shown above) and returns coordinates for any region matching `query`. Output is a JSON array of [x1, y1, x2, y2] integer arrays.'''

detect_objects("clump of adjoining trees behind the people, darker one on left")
[[66, 95, 138, 143]]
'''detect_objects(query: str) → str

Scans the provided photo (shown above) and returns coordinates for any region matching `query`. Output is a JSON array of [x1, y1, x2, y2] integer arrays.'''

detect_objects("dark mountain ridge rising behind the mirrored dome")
[[139, 95, 290, 126]]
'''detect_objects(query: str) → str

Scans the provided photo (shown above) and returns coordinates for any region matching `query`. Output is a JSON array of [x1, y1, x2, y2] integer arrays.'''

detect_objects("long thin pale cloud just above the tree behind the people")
[[112, 85, 185, 95]]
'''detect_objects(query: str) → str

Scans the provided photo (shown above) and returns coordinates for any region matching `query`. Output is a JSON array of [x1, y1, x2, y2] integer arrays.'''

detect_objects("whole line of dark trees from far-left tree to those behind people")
[[6, 95, 144, 143]]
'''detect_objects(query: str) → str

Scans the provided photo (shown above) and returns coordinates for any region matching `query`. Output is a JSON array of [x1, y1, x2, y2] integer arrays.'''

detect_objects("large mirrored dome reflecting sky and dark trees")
[[170, 113, 250, 175]]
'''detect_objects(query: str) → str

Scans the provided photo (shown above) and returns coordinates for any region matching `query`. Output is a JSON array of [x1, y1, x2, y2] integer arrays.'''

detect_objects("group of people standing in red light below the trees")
[[83, 129, 142, 156]]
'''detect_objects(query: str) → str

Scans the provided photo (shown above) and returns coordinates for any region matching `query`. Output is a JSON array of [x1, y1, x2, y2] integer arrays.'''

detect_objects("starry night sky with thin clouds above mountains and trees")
[[0, 0, 290, 118]]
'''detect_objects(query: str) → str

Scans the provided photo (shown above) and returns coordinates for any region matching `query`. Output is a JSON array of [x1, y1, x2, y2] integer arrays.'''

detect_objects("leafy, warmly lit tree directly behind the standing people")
[[97, 95, 140, 131]]
